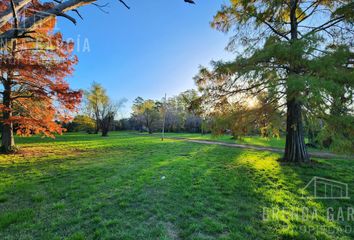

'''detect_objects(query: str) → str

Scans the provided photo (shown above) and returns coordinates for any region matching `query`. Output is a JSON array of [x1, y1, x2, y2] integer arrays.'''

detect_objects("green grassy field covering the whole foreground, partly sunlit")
[[0, 133, 354, 240]]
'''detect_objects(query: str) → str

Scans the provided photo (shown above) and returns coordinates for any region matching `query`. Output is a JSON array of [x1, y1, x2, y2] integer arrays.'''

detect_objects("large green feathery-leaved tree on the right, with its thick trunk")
[[196, 0, 354, 162]]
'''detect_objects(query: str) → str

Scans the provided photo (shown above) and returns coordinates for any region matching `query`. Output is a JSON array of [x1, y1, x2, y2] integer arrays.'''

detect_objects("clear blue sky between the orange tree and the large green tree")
[[57, 0, 233, 117]]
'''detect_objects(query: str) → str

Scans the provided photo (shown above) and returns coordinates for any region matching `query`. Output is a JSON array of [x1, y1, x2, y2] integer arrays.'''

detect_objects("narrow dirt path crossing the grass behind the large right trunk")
[[138, 134, 354, 159]]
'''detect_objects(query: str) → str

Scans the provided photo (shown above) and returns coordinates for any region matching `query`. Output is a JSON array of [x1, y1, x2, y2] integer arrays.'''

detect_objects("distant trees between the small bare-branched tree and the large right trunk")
[[118, 90, 284, 139]]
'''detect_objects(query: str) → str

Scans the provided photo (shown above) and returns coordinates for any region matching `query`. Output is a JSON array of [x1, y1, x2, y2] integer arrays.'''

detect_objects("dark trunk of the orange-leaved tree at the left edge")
[[1, 81, 15, 153]]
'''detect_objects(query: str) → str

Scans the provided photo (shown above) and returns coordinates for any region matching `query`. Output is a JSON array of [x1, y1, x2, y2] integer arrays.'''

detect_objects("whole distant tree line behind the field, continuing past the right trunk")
[[68, 83, 352, 158]]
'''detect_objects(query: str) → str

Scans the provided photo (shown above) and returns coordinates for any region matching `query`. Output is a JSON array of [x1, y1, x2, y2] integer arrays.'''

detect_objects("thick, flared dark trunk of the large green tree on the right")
[[284, 99, 310, 162]]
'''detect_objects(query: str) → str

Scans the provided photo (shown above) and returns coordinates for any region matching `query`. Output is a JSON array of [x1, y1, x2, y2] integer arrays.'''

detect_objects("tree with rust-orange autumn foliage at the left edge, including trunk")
[[0, 1, 82, 152]]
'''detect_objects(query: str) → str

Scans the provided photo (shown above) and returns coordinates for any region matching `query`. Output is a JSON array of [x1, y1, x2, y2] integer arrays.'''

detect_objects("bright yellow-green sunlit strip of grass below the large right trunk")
[[235, 152, 352, 239]]
